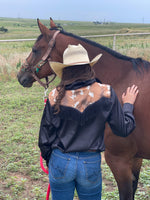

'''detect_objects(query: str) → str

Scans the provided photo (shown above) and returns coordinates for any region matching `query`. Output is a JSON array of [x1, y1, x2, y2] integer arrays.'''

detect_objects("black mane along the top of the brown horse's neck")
[[54, 28, 150, 72]]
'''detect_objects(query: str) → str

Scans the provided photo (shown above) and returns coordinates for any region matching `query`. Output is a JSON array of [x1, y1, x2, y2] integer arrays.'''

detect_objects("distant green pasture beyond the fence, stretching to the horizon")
[[0, 17, 150, 39]]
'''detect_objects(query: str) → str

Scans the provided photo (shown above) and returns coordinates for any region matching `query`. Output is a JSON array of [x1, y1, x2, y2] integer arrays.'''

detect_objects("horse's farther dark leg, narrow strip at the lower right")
[[132, 158, 142, 199]]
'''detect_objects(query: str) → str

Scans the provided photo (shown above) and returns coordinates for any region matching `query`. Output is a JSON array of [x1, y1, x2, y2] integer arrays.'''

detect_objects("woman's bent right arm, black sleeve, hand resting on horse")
[[108, 85, 138, 137]]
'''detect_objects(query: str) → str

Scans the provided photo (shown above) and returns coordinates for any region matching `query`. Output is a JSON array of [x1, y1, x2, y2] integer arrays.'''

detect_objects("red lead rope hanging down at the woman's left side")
[[40, 89, 51, 200]]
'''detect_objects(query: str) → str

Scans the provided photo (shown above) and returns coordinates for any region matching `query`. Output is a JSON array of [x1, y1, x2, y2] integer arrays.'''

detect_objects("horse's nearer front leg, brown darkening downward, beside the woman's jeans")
[[105, 151, 136, 200]]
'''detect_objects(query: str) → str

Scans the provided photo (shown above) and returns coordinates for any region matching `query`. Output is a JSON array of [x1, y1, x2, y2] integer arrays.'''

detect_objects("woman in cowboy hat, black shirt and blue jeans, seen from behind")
[[39, 44, 138, 200]]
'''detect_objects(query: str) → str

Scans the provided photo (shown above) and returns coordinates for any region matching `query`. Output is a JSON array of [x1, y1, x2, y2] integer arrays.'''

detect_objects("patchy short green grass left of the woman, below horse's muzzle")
[[0, 80, 56, 199]]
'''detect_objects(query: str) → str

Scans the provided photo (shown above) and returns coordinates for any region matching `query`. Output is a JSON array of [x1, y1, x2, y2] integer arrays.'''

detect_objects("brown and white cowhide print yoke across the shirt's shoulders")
[[49, 82, 111, 112]]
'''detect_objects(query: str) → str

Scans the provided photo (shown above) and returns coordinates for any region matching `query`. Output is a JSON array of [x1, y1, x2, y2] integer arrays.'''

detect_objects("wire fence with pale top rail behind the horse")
[[0, 32, 150, 73]]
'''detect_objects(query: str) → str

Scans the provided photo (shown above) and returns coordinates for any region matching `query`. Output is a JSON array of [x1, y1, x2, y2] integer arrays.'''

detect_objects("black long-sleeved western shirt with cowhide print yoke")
[[39, 80, 135, 164]]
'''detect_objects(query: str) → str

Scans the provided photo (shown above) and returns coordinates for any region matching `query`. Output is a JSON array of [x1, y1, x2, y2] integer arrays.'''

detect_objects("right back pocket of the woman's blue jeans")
[[83, 159, 101, 183]]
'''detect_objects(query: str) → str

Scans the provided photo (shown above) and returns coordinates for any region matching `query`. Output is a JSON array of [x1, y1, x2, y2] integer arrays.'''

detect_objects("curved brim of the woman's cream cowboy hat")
[[49, 54, 102, 78]]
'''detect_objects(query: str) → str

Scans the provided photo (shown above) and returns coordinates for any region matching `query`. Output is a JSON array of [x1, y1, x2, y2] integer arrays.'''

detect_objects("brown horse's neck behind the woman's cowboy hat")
[[57, 34, 132, 86]]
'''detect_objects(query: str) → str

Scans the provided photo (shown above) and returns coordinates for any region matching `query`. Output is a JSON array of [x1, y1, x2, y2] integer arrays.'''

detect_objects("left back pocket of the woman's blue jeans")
[[49, 153, 70, 179]]
